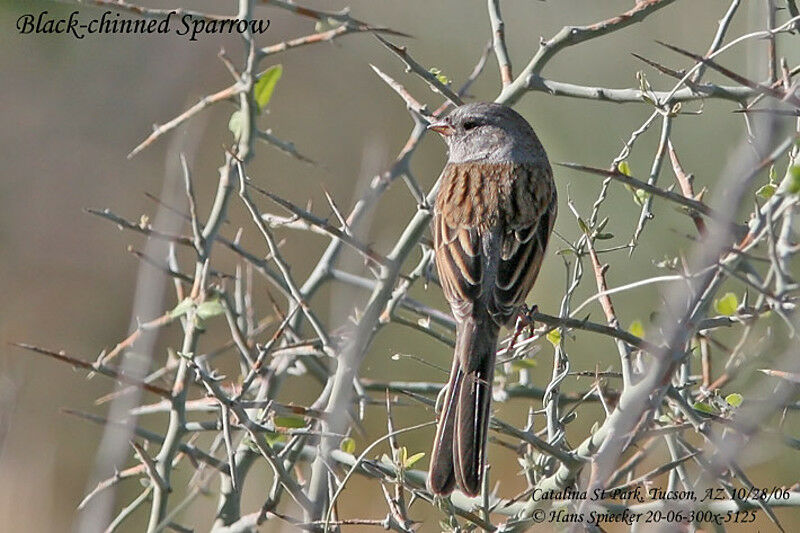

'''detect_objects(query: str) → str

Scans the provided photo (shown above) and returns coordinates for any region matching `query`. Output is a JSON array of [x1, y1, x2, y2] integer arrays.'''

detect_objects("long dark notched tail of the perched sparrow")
[[428, 317, 499, 496]]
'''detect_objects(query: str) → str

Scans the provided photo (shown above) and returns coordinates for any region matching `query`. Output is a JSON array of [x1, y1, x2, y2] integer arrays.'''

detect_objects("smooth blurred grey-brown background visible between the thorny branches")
[[0, 0, 800, 531]]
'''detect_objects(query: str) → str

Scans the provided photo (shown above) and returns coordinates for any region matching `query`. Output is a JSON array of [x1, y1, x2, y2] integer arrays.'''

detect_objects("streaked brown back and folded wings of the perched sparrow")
[[433, 162, 557, 325]]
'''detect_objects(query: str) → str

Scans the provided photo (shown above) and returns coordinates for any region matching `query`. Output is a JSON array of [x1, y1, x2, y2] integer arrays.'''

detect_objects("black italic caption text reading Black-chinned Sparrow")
[[17, 11, 270, 41]]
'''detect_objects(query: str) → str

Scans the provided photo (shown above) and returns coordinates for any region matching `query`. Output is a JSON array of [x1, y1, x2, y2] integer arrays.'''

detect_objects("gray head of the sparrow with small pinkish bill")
[[428, 102, 547, 163]]
